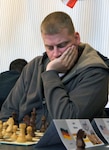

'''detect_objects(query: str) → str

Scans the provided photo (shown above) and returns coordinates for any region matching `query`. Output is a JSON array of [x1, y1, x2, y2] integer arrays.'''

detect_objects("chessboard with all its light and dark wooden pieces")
[[0, 109, 46, 145]]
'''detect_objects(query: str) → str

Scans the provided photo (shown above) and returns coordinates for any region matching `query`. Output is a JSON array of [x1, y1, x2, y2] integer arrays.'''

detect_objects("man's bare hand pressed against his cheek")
[[46, 46, 78, 73]]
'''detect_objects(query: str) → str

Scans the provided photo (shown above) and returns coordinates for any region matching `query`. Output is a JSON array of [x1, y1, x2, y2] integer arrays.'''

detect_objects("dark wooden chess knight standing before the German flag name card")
[[76, 129, 86, 150]]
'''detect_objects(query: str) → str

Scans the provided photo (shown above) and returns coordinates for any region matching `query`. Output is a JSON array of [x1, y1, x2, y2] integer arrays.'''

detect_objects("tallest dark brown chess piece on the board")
[[30, 108, 36, 137]]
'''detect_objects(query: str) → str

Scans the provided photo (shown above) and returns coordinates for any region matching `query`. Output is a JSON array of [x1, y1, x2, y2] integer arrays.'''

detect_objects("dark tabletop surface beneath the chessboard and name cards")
[[0, 144, 109, 150]]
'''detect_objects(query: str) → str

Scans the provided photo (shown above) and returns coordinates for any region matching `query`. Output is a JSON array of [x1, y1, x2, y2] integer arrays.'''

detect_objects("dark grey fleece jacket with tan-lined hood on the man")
[[0, 43, 109, 128]]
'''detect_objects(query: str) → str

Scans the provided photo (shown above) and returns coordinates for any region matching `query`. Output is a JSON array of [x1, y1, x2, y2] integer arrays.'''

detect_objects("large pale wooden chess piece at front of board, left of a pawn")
[[16, 123, 26, 143]]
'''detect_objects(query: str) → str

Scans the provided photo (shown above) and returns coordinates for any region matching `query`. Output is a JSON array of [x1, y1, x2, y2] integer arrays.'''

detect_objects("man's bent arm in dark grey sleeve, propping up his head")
[[42, 68, 108, 120]]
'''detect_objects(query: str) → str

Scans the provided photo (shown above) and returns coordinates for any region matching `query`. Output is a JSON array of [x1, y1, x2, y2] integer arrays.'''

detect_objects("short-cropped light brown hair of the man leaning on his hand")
[[41, 11, 75, 35]]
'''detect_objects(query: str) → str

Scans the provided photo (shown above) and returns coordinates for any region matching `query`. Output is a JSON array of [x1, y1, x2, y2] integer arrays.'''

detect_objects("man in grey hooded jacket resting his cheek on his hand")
[[0, 12, 108, 128]]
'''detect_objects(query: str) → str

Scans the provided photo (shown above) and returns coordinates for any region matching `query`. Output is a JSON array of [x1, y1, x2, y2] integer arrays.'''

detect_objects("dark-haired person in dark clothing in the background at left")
[[0, 58, 27, 109]]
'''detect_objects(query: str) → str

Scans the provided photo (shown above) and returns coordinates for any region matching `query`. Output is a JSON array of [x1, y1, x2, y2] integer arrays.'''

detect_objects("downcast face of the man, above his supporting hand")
[[42, 29, 79, 61]]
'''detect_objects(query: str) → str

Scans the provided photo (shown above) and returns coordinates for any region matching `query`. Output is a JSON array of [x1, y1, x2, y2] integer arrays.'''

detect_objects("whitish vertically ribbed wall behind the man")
[[0, 0, 109, 72]]
